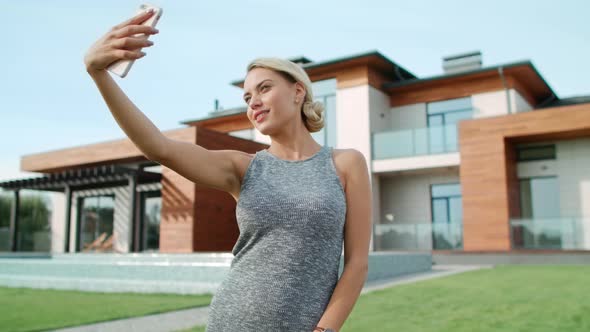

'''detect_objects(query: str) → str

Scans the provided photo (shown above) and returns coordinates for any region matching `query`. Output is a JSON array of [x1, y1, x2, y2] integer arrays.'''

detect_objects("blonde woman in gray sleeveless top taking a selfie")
[[84, 8, 371, 332]]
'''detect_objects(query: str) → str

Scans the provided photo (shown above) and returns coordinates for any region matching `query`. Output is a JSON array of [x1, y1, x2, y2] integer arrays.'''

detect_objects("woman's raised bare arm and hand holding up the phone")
[[84, 9, 247, 197]]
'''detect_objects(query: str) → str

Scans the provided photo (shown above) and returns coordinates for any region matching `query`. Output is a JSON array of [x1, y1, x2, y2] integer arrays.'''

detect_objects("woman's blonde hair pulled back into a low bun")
[[247, 58, 324, 133]]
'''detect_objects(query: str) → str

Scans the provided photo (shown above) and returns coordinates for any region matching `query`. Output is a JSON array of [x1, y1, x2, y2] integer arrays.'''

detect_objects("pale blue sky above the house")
[[0, 0, 590, 181]]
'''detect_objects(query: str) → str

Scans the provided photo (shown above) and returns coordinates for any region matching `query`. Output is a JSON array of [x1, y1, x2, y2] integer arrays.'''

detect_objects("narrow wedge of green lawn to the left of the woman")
[[0, 287, 212, 332]]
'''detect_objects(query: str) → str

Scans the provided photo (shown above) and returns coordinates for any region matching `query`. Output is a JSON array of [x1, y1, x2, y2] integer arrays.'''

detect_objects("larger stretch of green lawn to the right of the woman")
[[180, 265, 590, 332]]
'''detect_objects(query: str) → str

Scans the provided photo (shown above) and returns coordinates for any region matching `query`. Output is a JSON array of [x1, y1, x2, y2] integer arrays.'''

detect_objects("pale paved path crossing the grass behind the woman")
[[54, 265, 493, 332]]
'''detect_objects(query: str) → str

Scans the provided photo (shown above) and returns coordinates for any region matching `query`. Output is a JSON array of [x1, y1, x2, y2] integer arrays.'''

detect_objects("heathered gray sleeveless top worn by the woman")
[[206, 146, 346, 332]]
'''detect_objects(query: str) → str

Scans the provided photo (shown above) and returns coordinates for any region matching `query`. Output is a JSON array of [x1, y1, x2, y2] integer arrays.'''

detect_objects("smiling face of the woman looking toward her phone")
[[244, 67, 305, 135]]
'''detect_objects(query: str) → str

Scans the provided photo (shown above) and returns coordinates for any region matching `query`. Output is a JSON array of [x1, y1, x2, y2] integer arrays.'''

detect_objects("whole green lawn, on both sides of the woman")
[[0, 265, 590, 332]]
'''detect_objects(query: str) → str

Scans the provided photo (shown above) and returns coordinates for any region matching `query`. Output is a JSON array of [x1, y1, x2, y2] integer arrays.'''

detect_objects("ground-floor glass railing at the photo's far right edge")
[[510, 217, 590, 250]]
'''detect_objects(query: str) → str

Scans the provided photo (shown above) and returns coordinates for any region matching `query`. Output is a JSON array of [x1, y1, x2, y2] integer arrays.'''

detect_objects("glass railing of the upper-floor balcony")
[[371, 123, 458, 160]]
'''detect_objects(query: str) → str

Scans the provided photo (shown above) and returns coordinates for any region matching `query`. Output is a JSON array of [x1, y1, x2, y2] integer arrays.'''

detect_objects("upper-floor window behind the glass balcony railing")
[[426, 97, 473, 153]]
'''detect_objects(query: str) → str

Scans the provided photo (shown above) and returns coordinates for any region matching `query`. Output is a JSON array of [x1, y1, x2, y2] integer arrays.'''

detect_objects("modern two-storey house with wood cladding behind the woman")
[[0, 51, 590, 254]]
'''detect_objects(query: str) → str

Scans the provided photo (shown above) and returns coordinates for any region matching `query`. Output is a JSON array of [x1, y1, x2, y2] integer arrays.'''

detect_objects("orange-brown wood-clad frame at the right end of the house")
[[459, 104, 590, 251]]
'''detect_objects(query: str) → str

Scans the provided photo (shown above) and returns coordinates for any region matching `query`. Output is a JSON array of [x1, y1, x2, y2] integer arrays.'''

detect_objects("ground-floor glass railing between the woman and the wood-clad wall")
[[375, 220, 463, 250]]
